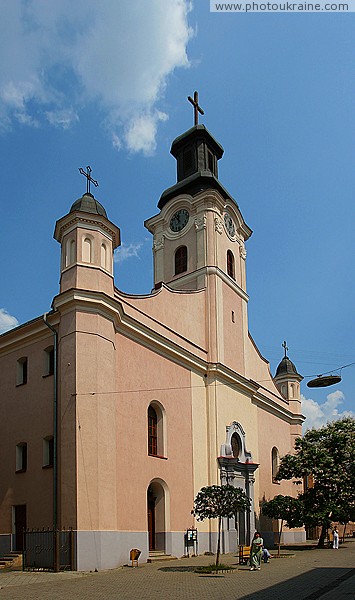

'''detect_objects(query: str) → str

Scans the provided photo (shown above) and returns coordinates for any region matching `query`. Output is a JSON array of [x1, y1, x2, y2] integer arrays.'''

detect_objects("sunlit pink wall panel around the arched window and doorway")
[[117, 337, 193, 531]]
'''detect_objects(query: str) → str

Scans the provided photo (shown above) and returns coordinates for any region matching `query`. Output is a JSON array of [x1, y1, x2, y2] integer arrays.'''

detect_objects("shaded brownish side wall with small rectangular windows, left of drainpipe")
[[0, 324, 53, 533]]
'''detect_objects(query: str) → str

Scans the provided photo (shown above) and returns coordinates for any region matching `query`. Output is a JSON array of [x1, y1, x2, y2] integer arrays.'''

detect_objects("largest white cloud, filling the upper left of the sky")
[[0, 0, 192, 154]]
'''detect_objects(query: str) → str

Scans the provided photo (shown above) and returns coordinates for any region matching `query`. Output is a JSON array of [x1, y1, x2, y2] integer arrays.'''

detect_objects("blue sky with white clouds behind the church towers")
[[0, 0, 355, 426]]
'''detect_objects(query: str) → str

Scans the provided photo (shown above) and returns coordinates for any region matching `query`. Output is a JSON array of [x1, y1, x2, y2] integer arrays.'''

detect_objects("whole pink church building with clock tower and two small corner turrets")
[[0, 105, 305, 570]]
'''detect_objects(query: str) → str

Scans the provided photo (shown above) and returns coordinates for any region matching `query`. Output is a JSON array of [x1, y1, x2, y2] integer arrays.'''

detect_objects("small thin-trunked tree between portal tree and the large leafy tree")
[[261, 494, 303, 556]]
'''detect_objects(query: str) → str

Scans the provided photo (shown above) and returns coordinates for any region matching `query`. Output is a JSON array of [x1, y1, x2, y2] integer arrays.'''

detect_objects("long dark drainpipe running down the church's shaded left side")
[[43, 313, 59, 571]]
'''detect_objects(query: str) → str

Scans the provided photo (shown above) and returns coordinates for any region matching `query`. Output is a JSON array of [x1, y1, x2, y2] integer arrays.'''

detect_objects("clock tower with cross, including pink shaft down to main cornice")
[[145, 93, 252, 374]]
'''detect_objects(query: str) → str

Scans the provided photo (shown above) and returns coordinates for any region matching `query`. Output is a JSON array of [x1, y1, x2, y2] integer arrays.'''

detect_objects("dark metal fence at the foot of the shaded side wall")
[[23, 529, 74, 571]]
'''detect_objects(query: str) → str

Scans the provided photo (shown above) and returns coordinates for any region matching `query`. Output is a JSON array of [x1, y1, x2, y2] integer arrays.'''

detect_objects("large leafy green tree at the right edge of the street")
[[276, 418, 355, 548]]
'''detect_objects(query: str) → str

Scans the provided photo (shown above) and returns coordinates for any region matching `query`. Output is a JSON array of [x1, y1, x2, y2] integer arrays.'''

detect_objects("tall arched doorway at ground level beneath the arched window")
[[147, 480, 166, 552]]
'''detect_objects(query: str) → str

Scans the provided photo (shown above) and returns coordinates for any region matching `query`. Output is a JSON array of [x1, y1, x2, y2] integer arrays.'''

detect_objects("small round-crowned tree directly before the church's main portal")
[[193, 485, 250, 567]]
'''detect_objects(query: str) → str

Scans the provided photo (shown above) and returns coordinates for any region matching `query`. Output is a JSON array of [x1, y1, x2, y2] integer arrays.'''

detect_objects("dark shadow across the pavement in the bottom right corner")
[[241, 567, 355, 600]]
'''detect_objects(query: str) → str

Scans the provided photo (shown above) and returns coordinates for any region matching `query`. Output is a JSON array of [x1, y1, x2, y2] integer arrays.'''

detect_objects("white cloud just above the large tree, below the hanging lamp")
[[301, 390, 355, 431]]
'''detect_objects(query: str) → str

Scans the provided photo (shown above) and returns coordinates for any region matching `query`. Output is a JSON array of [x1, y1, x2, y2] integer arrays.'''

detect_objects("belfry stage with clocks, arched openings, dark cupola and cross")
[[145, 92, 252, 297]]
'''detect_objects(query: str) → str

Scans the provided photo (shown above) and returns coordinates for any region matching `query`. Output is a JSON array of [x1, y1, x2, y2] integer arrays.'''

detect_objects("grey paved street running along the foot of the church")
[[0, 540, 355, 600]]
